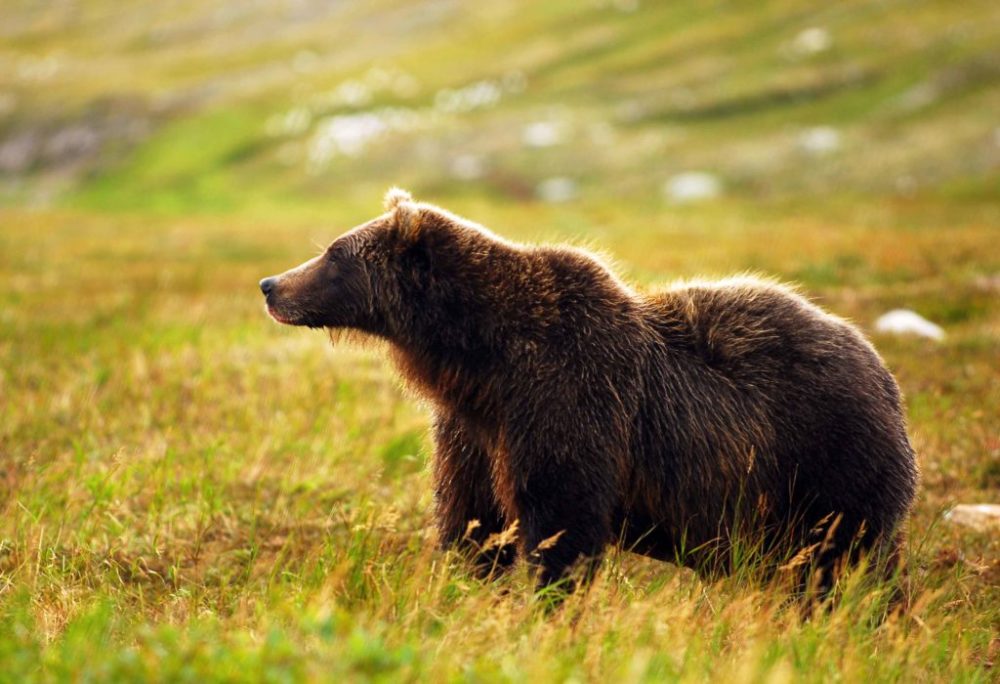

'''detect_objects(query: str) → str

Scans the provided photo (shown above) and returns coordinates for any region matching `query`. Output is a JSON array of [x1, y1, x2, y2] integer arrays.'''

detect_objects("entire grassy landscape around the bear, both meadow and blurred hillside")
[[0, 0, 1000, 682]]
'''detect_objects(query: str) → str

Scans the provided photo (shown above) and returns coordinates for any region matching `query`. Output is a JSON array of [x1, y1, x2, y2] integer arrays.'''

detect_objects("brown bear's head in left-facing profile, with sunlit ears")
[[260, 188, 490, 337]]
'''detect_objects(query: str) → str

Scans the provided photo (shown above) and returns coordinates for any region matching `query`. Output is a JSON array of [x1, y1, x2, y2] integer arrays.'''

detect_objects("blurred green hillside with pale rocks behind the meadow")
[[0, 0, 1000, 212]]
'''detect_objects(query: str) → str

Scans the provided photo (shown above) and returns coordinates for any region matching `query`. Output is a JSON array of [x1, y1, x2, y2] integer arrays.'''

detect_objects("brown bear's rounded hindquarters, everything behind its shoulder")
[[634, 277, 917, 560]]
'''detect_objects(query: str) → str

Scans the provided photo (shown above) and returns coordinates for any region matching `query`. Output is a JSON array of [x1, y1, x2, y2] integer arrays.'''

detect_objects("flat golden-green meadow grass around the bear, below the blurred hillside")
[[0, 198, 1000, 681]]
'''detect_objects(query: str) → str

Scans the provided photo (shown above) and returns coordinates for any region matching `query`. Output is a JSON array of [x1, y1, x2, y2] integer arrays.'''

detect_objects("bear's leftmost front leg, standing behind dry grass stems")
[[434, 415, 517, 578]]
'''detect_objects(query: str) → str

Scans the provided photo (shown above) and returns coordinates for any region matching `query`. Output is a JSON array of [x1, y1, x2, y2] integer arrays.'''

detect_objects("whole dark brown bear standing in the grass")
[[260, 189, 918, 586]]
